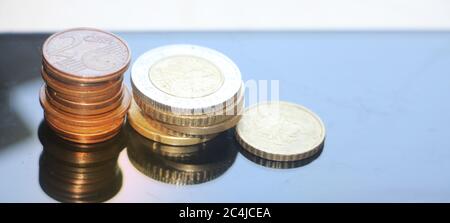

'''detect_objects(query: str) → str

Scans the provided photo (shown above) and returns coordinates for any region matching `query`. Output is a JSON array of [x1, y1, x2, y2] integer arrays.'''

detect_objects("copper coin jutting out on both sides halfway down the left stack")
[[39, 85, 131, 126]]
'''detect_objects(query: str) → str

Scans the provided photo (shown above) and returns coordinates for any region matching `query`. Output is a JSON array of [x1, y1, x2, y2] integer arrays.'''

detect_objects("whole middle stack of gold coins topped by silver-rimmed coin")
[[129, 45, 244, 145]]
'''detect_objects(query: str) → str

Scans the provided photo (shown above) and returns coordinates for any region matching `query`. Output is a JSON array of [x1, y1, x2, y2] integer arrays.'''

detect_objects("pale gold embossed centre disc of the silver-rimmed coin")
[[149, 55, 223, 98]]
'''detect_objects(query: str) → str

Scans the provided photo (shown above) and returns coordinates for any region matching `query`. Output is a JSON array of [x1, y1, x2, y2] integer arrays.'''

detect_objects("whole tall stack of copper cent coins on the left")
[[40, 28, 131, 143]]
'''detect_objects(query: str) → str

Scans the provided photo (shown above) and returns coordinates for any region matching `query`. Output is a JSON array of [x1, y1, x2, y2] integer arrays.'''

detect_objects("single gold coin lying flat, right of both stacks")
[[236, 101, 325, 161]]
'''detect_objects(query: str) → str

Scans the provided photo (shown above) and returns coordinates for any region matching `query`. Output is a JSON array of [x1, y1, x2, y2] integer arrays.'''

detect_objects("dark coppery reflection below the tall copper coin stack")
[[38, 122, 125, 202]]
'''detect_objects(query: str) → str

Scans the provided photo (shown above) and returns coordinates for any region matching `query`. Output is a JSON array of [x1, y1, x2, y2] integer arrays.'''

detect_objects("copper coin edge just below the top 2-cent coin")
[[41, 68, 123, 98]]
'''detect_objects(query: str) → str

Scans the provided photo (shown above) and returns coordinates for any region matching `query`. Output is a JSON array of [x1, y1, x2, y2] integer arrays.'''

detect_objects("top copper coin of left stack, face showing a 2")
[[42, 28, 131, 83]]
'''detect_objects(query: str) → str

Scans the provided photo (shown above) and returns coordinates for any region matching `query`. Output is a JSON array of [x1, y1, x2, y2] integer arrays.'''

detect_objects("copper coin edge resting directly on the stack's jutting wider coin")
[[46, 85, 124, 115]]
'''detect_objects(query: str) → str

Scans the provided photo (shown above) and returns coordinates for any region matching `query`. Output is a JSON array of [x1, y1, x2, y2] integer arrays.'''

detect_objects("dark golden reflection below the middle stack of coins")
[[127, 125, 237, 185]]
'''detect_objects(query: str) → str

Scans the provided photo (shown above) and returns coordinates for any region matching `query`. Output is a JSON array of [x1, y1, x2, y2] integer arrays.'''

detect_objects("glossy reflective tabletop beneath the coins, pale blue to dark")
[[0, 32, 450, 202]]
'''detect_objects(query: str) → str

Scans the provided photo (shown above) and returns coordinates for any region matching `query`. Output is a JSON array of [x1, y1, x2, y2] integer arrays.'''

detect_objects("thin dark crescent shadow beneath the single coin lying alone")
[[236, 142, 324, 169]]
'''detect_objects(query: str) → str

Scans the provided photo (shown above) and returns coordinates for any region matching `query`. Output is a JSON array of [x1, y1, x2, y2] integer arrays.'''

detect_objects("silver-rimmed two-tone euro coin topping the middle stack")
[[131, 45, 242, 116]]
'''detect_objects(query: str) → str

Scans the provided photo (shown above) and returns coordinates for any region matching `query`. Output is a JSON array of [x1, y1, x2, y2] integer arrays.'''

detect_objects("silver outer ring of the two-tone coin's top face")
[[131, 44, 242, 110]]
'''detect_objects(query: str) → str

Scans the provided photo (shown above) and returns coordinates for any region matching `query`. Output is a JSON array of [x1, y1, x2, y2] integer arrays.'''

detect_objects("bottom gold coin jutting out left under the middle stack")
[[128, 101, 216, 146]]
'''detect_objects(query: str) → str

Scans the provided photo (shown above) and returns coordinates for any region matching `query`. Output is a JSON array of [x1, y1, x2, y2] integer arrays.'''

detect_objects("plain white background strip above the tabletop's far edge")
[[0, 0, 450, 32]]
